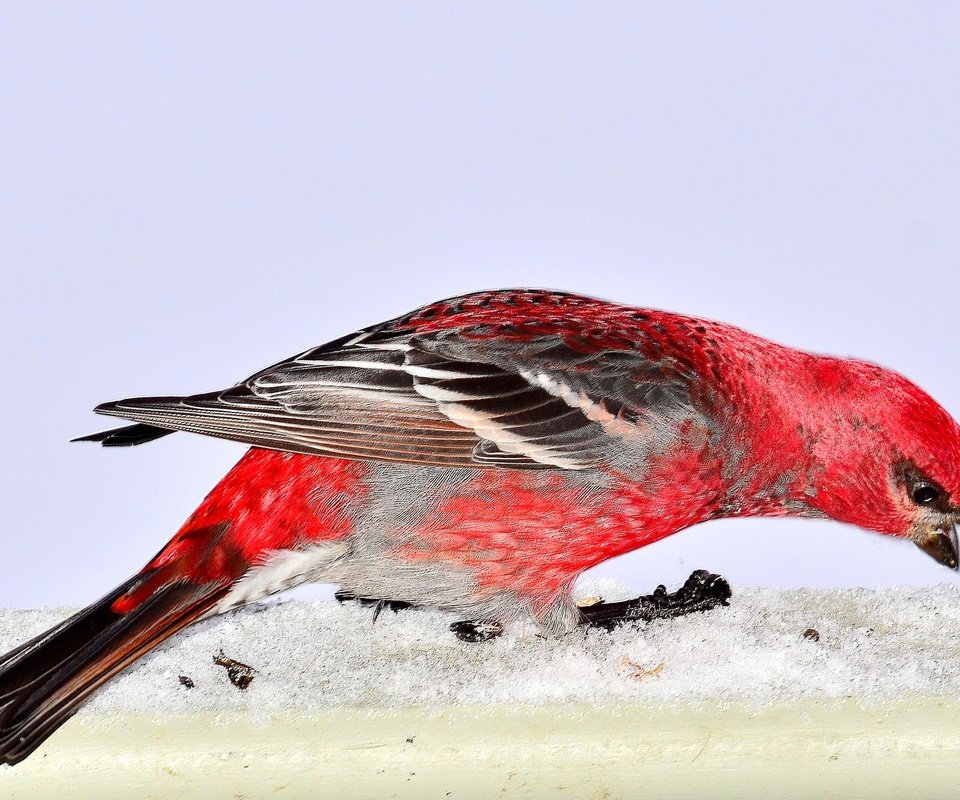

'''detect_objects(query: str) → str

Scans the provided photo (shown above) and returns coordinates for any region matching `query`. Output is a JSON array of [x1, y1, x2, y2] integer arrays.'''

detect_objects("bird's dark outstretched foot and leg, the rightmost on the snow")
[[579, 569, 730, 630]]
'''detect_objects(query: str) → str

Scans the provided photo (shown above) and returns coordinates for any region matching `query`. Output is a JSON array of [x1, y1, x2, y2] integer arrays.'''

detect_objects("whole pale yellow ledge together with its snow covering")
[[0, 581, 960, 800]]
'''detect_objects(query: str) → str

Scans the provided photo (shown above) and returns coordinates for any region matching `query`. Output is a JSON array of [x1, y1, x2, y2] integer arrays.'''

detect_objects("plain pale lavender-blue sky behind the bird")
[[0, 0, 960, 607]]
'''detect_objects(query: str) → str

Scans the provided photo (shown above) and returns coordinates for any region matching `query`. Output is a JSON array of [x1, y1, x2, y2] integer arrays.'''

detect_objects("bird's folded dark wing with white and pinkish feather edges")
[[88, 290, 696, 470]]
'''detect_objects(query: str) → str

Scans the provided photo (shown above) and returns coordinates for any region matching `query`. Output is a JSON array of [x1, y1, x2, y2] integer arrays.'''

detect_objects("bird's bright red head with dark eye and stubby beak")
[[810, 359, 960, 569]]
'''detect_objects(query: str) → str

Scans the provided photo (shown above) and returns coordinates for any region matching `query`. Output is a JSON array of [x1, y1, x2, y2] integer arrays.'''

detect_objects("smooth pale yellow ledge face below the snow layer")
[[0, 698, 960, 800]]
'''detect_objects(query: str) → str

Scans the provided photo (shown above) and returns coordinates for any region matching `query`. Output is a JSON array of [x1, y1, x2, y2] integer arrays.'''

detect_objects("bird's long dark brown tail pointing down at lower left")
[[0, 574, 228, 764]]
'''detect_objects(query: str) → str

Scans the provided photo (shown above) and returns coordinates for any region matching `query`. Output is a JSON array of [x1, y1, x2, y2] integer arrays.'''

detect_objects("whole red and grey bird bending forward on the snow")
[[0, 290, 960, 764]]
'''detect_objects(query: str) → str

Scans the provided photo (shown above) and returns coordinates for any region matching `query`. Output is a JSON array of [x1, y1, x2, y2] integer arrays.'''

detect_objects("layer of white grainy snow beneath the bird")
[[0, 579, 960, 719]]
